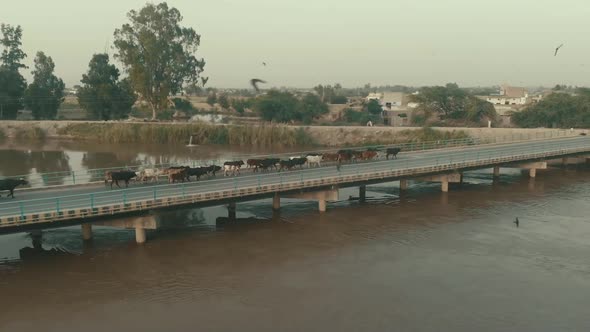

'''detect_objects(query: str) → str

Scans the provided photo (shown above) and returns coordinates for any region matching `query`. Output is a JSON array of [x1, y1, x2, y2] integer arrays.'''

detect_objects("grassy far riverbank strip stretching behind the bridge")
[[0, 121, 586, 147]]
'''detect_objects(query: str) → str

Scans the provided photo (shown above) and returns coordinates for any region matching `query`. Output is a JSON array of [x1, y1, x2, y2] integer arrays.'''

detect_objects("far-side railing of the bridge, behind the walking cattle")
[[0, 130, 572, 188]]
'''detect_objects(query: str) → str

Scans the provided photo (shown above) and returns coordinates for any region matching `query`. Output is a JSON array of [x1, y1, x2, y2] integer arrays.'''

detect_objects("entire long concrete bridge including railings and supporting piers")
[[0, 136, 590, 243]]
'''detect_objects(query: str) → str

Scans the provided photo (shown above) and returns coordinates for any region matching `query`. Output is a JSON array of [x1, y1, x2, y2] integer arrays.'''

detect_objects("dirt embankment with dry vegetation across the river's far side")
[[0, 121, 587, 146]]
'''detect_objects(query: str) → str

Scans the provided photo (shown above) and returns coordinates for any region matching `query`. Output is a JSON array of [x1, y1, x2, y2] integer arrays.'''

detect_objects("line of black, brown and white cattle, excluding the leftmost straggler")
[[104, 148, 401, 189]]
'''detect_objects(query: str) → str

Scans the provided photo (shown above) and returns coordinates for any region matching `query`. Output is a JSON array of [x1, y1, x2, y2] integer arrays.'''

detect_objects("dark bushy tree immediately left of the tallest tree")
[[78, 54, 136, 120]]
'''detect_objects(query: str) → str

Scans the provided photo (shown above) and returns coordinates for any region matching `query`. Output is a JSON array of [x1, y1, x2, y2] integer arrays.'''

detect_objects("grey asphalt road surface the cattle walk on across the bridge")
[[0, 136, 590, 217]]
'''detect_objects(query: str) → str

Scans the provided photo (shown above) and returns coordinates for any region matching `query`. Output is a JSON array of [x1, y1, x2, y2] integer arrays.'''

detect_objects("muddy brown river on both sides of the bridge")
[[0, 142, 590, 332]]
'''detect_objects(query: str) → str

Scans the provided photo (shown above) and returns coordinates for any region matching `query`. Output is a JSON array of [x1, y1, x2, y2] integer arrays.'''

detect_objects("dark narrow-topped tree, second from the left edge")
[[25, 51, 65, 120]]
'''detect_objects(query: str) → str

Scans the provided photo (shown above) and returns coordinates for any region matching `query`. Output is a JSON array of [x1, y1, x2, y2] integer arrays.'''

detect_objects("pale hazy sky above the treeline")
[[0, 0, 590, 88]]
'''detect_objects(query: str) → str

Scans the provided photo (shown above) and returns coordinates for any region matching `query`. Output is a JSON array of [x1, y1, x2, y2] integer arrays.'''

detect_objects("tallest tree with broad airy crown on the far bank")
[[114, 2, 207, 119]]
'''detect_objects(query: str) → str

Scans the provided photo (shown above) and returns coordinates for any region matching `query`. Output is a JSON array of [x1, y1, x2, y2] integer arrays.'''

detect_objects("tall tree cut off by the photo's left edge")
[[0, 24, 27, 120]]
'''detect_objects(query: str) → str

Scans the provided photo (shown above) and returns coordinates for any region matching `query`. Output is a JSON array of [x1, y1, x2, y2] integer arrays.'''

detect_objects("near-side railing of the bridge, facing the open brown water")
[[0, 136, 590, 227]]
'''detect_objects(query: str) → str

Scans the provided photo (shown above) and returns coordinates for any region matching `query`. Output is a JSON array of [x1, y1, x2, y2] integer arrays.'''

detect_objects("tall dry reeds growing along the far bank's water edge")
[[58, 123, 314, 147]]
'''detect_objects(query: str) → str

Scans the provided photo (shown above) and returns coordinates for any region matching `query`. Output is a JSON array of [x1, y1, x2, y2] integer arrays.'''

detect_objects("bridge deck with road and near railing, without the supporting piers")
[[0, 137, 590, 231]]
